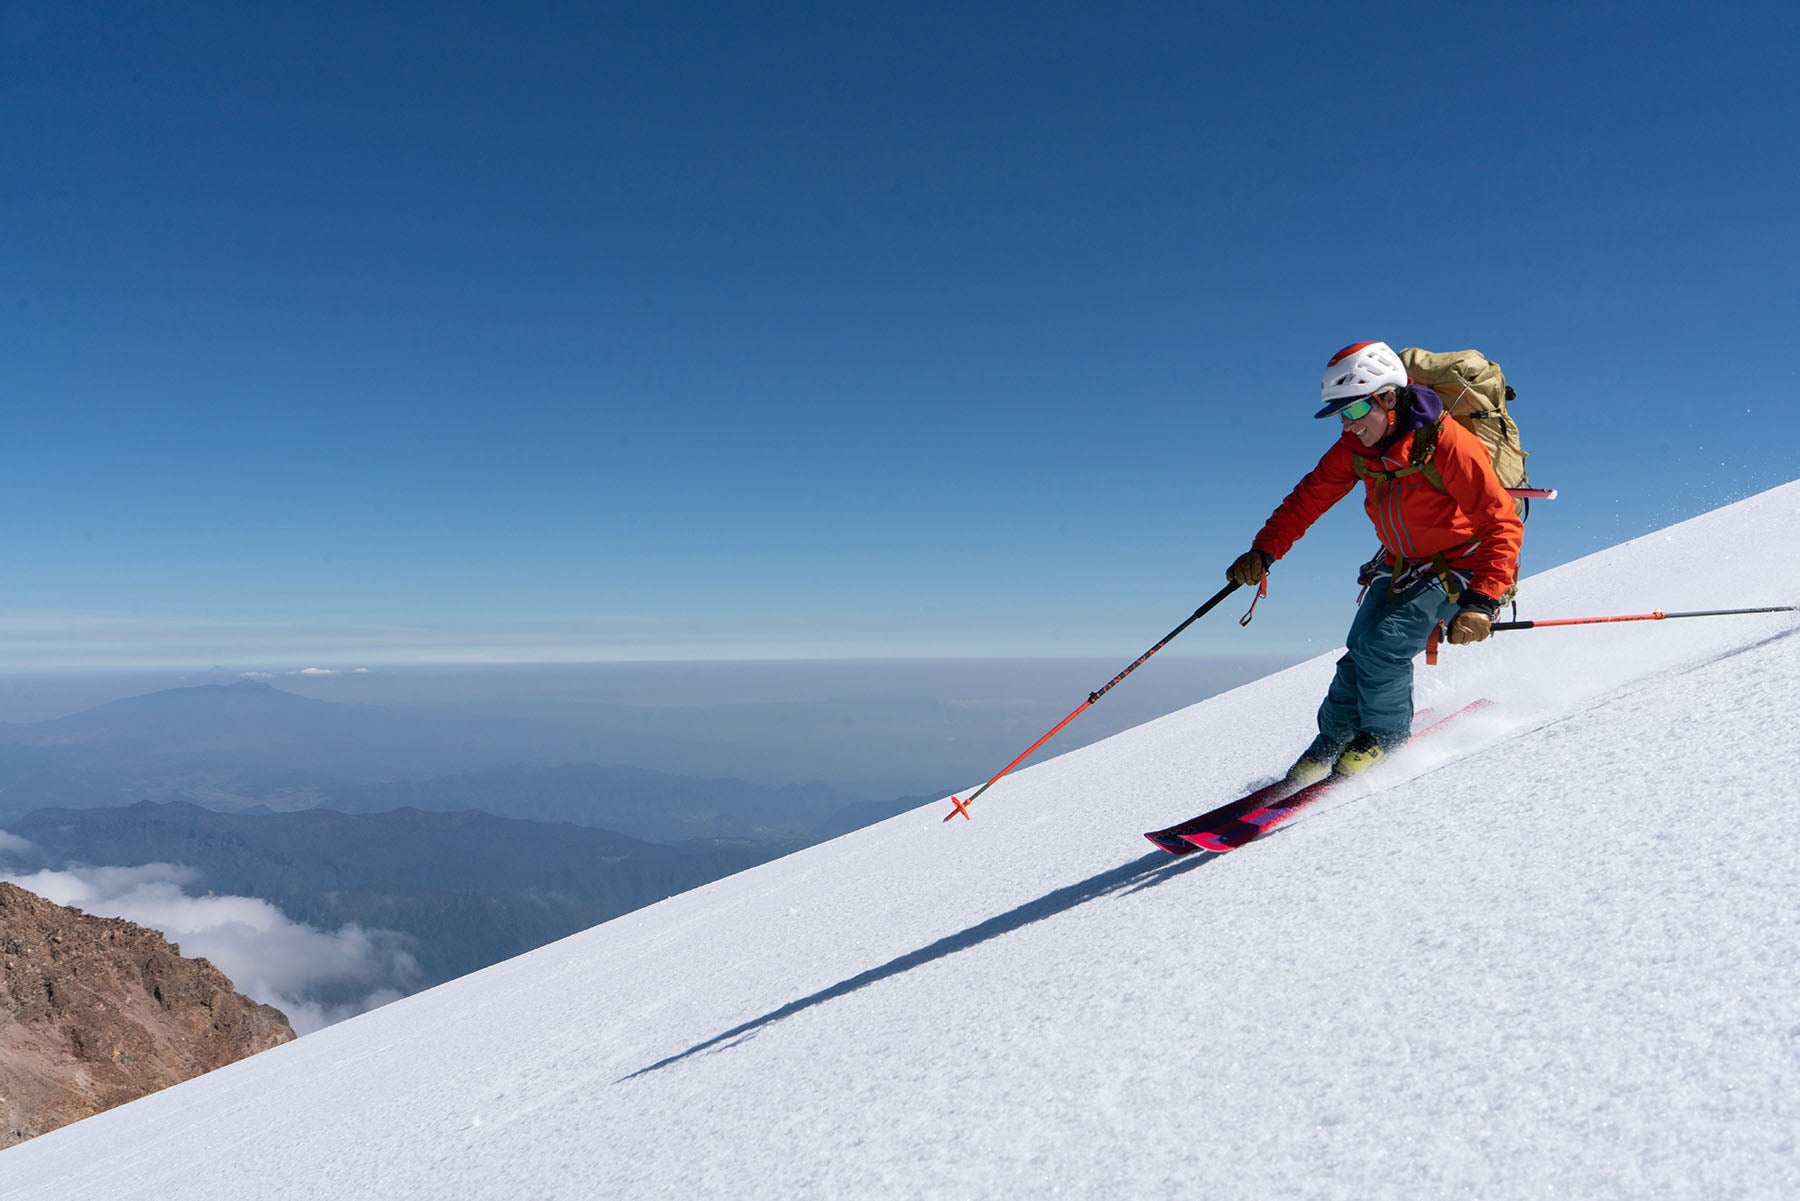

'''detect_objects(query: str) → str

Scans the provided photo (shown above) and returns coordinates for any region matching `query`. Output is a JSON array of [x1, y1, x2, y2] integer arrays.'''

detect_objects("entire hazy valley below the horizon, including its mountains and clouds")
[[0, 664, 1251, 1032]]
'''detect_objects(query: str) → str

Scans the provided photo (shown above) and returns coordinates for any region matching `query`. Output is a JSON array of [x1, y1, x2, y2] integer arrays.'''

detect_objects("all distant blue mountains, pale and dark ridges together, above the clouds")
[[0, 682, 931, 1010]]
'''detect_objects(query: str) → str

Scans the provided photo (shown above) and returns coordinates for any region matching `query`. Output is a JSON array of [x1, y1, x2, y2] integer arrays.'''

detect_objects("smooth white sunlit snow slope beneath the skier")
[[0, 484, 1800, 1201]]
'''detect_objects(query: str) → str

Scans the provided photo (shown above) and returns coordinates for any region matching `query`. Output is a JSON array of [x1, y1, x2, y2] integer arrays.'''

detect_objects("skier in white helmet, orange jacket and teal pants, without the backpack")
[[1226, 342, 1525, 787]]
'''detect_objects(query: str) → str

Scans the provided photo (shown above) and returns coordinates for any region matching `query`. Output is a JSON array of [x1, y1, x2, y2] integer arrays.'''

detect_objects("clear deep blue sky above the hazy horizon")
[[0, 2, 1800, 682]]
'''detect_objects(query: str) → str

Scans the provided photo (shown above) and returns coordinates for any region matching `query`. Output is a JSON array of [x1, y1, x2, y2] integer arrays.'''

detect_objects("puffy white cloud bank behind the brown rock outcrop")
[[0, 864, 419, 1034]]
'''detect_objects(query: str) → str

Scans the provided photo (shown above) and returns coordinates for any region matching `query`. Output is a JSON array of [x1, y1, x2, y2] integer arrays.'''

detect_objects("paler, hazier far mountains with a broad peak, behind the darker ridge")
[[0, 682, 931, 841]]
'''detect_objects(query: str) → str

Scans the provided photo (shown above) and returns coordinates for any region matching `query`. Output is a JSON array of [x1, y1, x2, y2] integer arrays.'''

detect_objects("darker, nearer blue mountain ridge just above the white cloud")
[[0, 801, 799, 1005]]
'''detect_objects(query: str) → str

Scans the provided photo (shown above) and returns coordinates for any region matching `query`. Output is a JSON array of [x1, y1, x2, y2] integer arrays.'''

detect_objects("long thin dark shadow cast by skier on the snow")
[[621, 850, 1219, 1082]]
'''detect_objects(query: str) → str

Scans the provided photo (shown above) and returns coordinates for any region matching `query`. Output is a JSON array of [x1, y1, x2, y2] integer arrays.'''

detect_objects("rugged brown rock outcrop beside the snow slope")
[[0, 882, 293, 1147]]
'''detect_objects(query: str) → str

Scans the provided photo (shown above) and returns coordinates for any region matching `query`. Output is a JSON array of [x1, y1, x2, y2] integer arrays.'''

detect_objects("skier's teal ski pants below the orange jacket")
[[1319, 574, 1458, 749]]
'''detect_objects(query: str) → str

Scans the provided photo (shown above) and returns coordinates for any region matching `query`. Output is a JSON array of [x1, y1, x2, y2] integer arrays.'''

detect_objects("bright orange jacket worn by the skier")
[[1251, 403, 1525, 600]]
